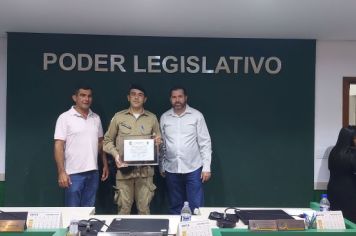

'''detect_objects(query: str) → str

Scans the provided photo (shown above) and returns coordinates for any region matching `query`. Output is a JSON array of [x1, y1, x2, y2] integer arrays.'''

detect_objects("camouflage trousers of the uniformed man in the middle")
[[115, 177, 156, 215]]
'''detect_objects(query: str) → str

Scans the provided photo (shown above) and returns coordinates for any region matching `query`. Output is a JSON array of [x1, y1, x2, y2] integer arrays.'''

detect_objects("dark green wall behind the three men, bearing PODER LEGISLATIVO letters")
[[5, 33, 315, 213]]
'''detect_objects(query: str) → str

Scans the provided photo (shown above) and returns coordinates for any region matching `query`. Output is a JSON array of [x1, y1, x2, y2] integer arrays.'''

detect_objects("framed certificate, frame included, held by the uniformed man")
[[123, 136, 158, 166]]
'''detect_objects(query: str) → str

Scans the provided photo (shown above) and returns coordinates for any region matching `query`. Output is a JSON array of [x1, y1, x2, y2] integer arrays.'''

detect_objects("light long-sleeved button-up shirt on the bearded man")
[[160, 105, 211, 174]]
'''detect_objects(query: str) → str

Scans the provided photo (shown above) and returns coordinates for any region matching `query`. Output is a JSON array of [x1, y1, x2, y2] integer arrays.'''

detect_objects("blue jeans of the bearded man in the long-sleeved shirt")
[[166, 168, 204, 215]]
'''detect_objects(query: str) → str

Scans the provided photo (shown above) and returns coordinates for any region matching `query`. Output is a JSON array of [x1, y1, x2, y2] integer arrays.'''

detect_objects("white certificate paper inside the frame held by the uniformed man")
[[124, 139, 155, 162]]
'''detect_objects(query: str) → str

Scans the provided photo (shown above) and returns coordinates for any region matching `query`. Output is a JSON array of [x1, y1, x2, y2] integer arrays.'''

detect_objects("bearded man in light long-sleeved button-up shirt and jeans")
[[160, 87, 211, 214]]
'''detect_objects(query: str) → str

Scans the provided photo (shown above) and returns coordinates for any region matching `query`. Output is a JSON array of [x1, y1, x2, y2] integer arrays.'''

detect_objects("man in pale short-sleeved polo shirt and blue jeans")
[[54, 86, 109, 207]]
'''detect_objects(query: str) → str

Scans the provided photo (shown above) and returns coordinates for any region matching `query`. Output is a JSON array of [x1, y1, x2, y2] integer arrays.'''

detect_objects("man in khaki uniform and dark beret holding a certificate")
[[103, 85, 161, 215]]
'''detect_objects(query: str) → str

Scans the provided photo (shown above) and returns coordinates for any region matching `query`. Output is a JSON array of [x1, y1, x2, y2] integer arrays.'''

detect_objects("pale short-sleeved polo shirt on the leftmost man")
[[54, 107, 103, 174]]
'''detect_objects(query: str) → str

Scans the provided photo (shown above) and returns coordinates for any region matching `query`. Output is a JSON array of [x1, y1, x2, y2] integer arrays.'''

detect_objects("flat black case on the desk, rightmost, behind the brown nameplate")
[[235, 210, 294, 225]]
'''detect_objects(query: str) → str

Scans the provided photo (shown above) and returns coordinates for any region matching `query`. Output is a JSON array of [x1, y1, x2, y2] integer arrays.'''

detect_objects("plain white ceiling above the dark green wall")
[[0, 0, 356, 40]]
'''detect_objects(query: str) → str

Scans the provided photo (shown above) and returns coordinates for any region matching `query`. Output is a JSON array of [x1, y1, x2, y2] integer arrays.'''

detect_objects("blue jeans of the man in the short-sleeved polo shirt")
[[64, 170, 99, 207]]
